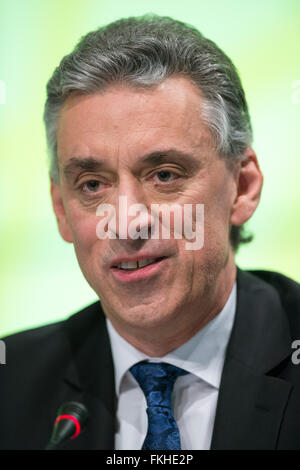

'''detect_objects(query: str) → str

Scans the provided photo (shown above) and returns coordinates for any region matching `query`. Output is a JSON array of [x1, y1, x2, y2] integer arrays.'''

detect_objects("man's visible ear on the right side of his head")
[[230, 147, 263, 225]]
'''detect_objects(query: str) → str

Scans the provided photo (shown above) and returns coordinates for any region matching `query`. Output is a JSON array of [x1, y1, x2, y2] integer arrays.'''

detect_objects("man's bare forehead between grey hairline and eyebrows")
[[57, 77, 211, 162]]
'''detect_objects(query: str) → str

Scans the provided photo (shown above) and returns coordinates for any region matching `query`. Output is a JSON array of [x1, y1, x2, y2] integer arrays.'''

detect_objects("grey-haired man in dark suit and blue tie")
[[0, 16, 300, 449]]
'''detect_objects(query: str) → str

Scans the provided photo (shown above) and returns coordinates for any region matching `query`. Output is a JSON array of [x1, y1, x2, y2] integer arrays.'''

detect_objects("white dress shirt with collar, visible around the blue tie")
[[106, 283, 236, 450]]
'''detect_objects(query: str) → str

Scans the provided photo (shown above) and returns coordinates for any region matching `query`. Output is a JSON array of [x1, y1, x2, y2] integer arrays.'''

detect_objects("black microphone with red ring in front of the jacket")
[[45, 401, 89, 450]]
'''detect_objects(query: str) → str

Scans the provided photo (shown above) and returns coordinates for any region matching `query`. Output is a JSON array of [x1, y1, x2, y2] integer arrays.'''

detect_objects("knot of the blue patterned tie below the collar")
[[130, 361, 187, 408]]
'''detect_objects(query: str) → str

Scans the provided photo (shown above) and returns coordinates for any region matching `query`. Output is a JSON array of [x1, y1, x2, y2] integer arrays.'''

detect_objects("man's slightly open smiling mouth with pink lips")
[[111, 256, 167, 282]]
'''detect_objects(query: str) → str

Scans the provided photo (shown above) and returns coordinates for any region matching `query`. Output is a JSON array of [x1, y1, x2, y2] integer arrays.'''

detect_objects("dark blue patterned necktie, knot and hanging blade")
[[130, 361, 187, 450]]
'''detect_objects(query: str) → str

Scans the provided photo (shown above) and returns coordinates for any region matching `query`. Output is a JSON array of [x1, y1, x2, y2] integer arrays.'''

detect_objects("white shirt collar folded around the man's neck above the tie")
[[106, 282, 236, 395]]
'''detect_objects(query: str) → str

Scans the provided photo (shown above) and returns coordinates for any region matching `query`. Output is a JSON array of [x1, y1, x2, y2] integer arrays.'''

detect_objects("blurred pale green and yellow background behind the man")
[[0, 0, 300, 336]]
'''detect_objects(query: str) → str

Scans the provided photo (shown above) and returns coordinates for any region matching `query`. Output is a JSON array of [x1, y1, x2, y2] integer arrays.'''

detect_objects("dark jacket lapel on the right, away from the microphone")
[[211, 269, 292, 449]]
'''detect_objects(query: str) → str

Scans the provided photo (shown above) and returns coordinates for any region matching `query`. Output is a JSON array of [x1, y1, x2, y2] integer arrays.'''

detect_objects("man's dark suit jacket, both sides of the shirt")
[[0, 269, 300, 450]]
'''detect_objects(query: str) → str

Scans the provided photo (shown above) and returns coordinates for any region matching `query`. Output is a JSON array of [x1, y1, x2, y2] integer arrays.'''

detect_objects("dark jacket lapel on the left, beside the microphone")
[[58, 302, 116, 450]]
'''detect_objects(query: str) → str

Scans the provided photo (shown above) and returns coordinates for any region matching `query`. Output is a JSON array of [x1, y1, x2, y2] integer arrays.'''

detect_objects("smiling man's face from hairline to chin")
[[52, 77, 248, 344]]
